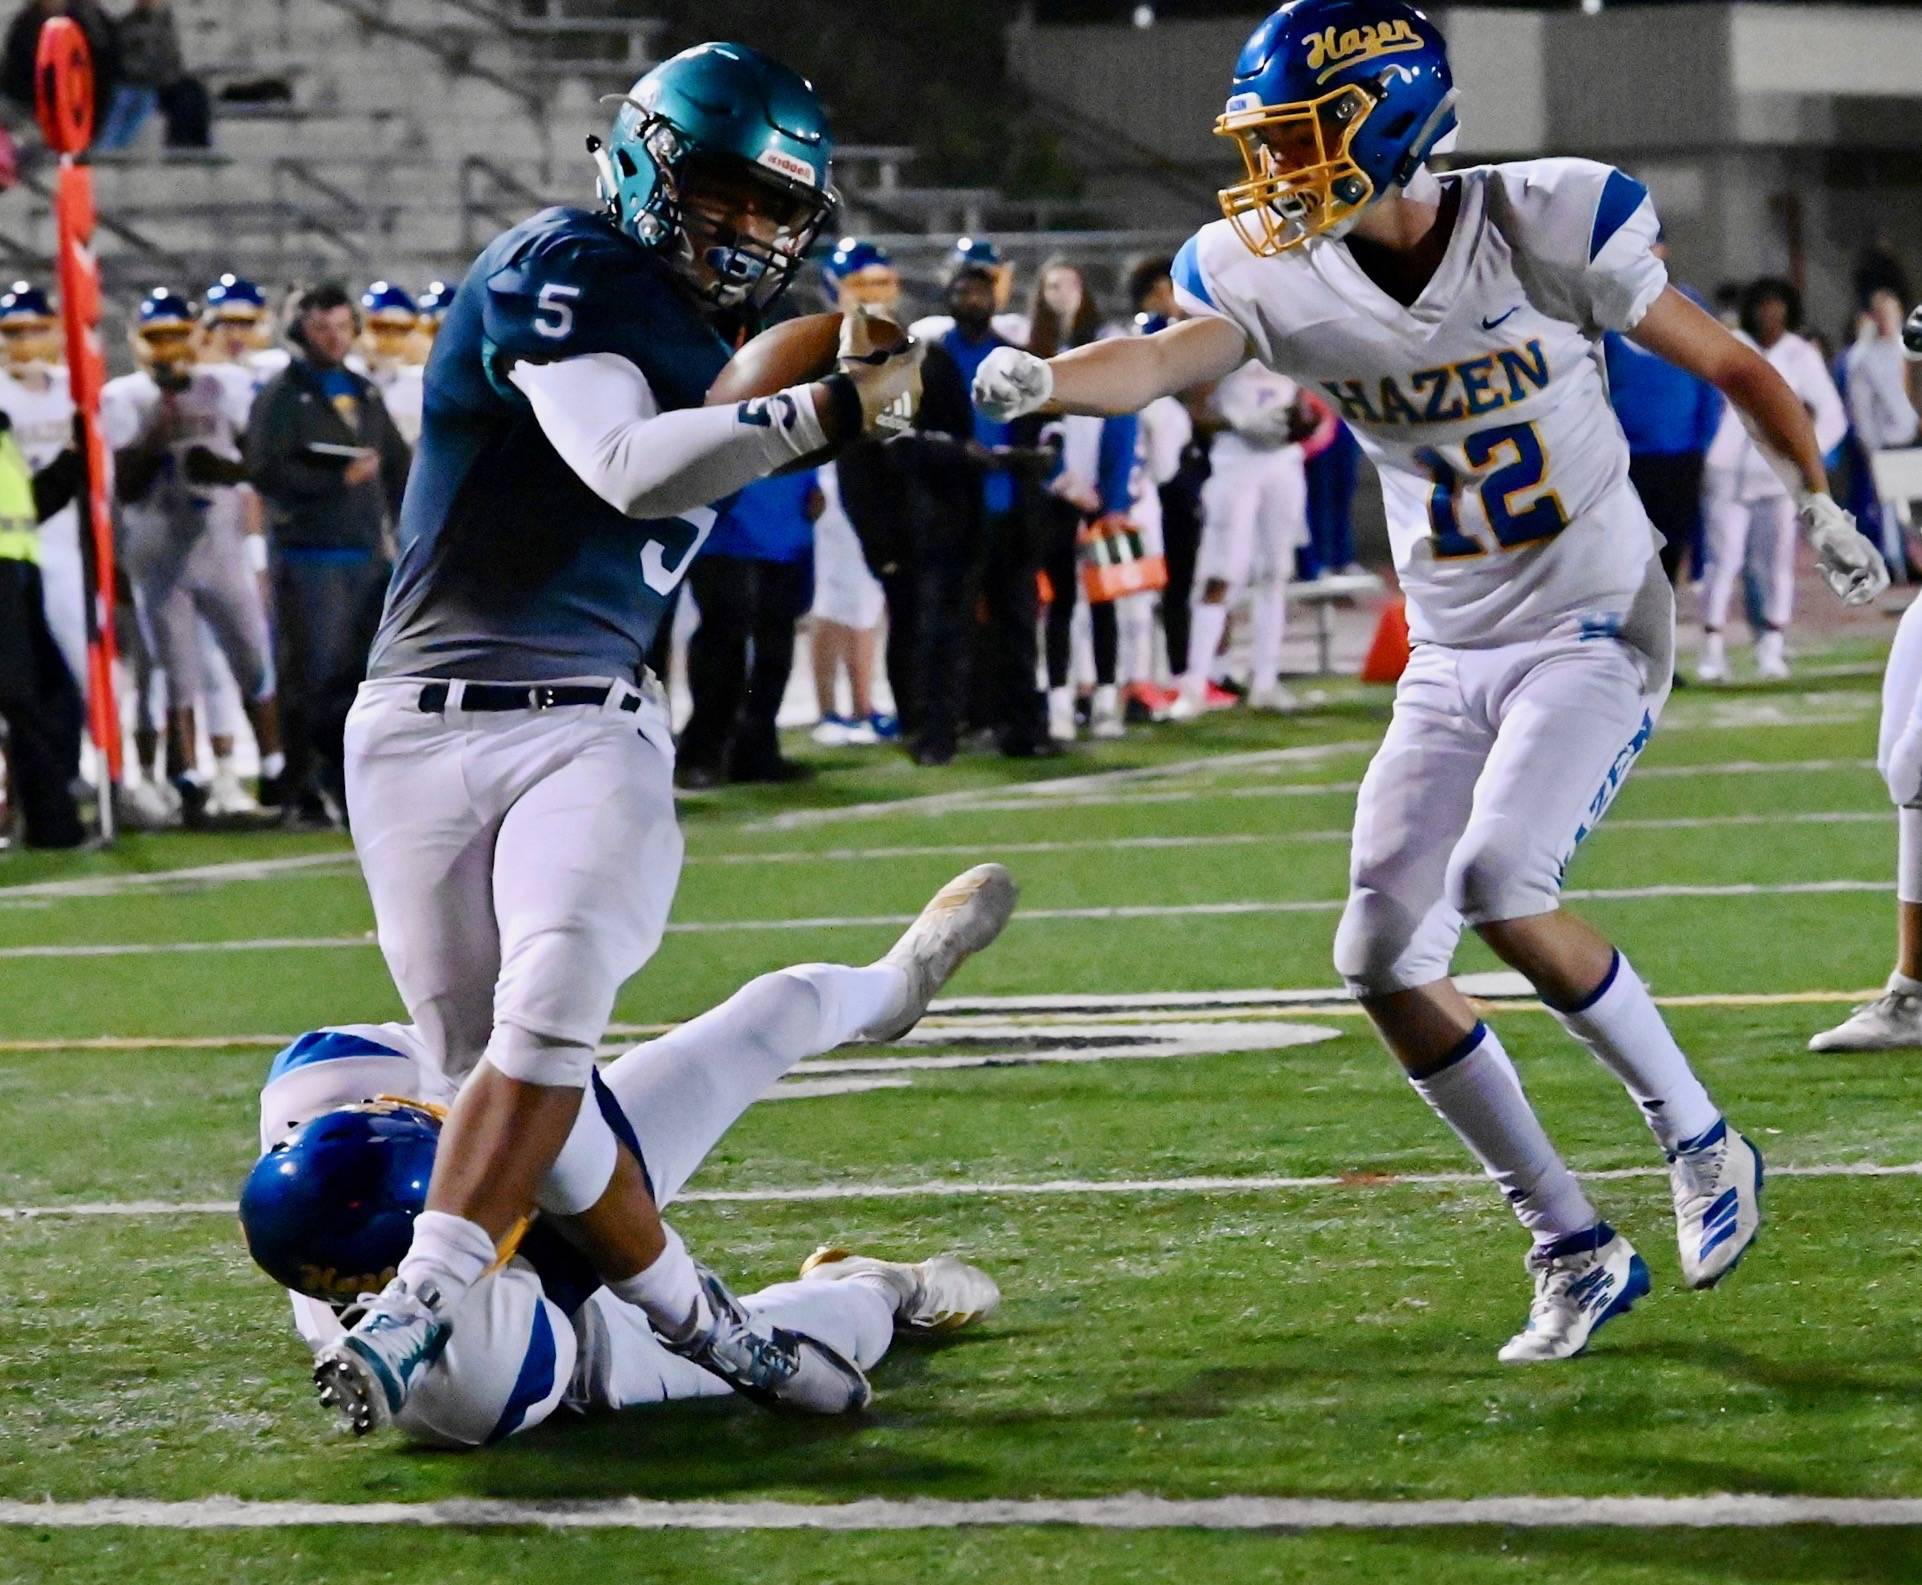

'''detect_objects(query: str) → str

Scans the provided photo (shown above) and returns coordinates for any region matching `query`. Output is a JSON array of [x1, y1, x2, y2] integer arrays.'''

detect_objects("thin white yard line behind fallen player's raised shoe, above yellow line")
[[0, 880, 1895, 961]]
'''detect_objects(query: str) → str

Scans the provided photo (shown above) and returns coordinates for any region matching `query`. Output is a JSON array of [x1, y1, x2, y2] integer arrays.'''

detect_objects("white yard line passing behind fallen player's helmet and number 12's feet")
[[0, 1160, 1922, 1222]]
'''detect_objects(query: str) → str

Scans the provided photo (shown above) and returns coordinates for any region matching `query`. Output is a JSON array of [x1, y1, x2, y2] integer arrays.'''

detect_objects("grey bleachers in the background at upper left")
[[0, 0, 1178, 334]]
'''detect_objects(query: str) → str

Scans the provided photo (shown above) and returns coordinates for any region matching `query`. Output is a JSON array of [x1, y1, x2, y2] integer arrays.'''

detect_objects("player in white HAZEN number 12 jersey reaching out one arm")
[[974, 0, 1887, 1360]]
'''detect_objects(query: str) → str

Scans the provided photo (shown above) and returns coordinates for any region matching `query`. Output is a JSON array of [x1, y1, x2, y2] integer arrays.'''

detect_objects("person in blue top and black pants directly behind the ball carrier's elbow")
[[675, 473, 823, 788]]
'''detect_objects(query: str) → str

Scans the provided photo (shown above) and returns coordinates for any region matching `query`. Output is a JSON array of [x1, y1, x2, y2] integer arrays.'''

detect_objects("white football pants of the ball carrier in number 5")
[[346, 678, 682, 1085]]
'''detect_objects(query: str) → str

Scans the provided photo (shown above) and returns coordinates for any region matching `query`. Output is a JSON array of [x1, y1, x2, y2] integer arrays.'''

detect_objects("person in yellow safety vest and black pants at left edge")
[[0, 413, 86, 847]]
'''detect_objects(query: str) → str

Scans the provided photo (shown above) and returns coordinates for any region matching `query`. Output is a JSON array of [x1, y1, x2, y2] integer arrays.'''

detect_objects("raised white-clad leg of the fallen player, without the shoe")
[[602, 963, 907, 1205]]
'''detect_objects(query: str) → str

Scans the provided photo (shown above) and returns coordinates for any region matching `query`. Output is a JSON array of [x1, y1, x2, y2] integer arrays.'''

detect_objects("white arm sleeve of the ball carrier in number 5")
[[509, 352, 826, 517]]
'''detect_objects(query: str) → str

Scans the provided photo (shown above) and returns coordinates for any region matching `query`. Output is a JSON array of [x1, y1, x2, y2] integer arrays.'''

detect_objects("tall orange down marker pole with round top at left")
[[35, 17, 121, 836]]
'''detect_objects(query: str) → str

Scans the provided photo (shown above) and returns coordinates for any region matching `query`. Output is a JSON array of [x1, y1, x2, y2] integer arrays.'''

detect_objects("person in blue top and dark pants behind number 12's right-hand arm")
[[1603, 238, 1722, 584]]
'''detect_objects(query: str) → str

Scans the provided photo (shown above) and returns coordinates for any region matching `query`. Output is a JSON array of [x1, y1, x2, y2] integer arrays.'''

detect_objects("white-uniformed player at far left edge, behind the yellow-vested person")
[[0, 280, 86, 695]]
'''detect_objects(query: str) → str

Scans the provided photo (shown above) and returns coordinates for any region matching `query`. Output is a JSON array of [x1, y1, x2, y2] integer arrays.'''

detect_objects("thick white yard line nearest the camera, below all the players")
[[0, 1493, 1922, 1531]]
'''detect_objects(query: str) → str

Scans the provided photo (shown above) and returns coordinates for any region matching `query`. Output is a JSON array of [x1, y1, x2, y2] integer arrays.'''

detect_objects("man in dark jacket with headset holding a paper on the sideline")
[[246, 282, 411, 824]]
